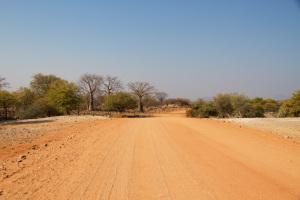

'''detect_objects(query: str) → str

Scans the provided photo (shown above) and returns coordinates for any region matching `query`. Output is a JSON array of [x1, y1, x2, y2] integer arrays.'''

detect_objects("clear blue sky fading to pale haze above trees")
[[0, 0, 300, 99]]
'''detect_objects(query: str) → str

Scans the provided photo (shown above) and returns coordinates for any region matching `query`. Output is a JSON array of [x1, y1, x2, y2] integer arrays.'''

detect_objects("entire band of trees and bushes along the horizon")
[[0, 73, 300, 120]]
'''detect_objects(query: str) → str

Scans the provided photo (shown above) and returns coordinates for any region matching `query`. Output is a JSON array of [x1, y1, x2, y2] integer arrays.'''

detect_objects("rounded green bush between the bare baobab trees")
[[103, 92, 137, 112]]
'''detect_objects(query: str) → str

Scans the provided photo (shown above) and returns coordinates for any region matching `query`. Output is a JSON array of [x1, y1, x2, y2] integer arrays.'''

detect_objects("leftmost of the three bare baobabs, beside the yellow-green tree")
[[79, 74, 103, 111]]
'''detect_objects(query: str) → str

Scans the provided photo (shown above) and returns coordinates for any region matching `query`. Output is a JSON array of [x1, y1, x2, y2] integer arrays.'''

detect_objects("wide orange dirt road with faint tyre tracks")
[[0, 115, 300, 200]]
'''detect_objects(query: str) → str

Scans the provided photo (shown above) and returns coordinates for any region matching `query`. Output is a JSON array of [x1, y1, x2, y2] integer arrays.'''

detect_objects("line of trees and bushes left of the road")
[[0, 73, 173, 120]]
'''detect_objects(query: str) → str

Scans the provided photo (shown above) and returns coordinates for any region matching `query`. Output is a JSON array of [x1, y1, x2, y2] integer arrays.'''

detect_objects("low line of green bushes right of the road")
[[187, 91, 300, 118]]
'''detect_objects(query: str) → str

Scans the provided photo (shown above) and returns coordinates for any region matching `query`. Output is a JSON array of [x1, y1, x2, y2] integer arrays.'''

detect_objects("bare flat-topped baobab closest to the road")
[[128, 82, 155, 112]]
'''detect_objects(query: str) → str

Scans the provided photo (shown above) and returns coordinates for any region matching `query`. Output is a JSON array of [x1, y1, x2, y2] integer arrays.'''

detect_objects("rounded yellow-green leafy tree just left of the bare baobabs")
[[46, 80, 80, 114]]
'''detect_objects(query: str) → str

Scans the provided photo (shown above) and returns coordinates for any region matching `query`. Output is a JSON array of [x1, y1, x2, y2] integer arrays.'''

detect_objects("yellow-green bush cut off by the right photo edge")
[[278, 90, 300, 117]]
